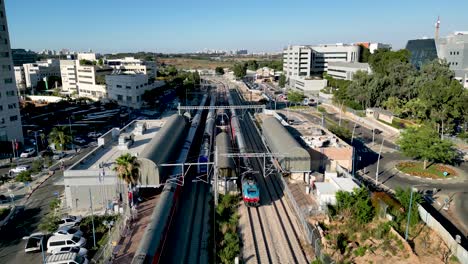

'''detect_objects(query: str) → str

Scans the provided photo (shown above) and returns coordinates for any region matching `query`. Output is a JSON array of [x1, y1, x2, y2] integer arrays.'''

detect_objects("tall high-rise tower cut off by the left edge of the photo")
[[0, 1, 23, 142]]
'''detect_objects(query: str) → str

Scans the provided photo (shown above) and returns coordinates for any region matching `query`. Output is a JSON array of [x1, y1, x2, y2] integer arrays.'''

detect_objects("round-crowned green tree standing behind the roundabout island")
[[397, 126, 456, 169]]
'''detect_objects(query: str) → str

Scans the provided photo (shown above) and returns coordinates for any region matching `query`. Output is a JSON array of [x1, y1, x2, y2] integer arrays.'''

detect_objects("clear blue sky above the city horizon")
[[5, 0, 468, 52]]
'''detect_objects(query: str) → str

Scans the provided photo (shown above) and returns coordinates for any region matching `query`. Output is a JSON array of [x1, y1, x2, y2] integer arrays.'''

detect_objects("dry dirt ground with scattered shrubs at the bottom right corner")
[[318, 217, 456, 264]]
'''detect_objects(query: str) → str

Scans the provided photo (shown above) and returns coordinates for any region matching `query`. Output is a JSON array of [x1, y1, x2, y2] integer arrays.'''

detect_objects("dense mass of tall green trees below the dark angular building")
[[332, 50, 468, 134]]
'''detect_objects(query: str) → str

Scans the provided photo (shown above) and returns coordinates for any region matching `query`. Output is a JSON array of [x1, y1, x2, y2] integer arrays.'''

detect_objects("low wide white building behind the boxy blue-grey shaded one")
[[106, 57, 157, 78]]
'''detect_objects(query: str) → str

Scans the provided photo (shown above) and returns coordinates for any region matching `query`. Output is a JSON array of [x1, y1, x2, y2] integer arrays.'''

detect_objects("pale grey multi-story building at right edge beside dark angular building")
[[436, 31, 468, 88]]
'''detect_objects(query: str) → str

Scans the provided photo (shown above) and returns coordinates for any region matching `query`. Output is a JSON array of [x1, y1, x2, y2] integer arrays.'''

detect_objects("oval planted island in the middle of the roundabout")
[[396, 161, 457, 179]]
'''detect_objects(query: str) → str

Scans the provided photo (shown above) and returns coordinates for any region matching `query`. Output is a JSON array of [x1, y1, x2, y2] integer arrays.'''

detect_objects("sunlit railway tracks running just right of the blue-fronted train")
[[229, 85, 307, 263]]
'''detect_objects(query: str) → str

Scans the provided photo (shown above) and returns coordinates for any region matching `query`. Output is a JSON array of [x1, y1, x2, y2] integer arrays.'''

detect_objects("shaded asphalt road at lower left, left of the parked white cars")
[[0, 148, 91, 263]]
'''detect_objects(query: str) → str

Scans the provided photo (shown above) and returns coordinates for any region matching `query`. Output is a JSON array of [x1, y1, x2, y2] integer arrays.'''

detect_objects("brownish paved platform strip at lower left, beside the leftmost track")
[[113, 194, 159, 264]]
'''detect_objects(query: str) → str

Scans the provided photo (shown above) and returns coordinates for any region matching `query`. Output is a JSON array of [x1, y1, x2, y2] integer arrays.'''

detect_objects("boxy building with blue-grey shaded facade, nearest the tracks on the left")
[[106, 70, 164, 109]]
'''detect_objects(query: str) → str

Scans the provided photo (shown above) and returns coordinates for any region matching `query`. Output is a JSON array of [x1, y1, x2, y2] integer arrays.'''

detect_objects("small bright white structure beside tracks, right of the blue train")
[[315, 172, 359, 209]]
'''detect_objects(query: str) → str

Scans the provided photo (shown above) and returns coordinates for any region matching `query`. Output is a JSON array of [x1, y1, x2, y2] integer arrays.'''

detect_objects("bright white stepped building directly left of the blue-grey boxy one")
[[76, 63, 113, 100]]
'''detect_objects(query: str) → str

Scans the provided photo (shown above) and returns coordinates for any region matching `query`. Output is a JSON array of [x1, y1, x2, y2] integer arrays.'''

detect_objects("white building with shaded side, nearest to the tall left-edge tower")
[[23, 59, 60, 88]]
